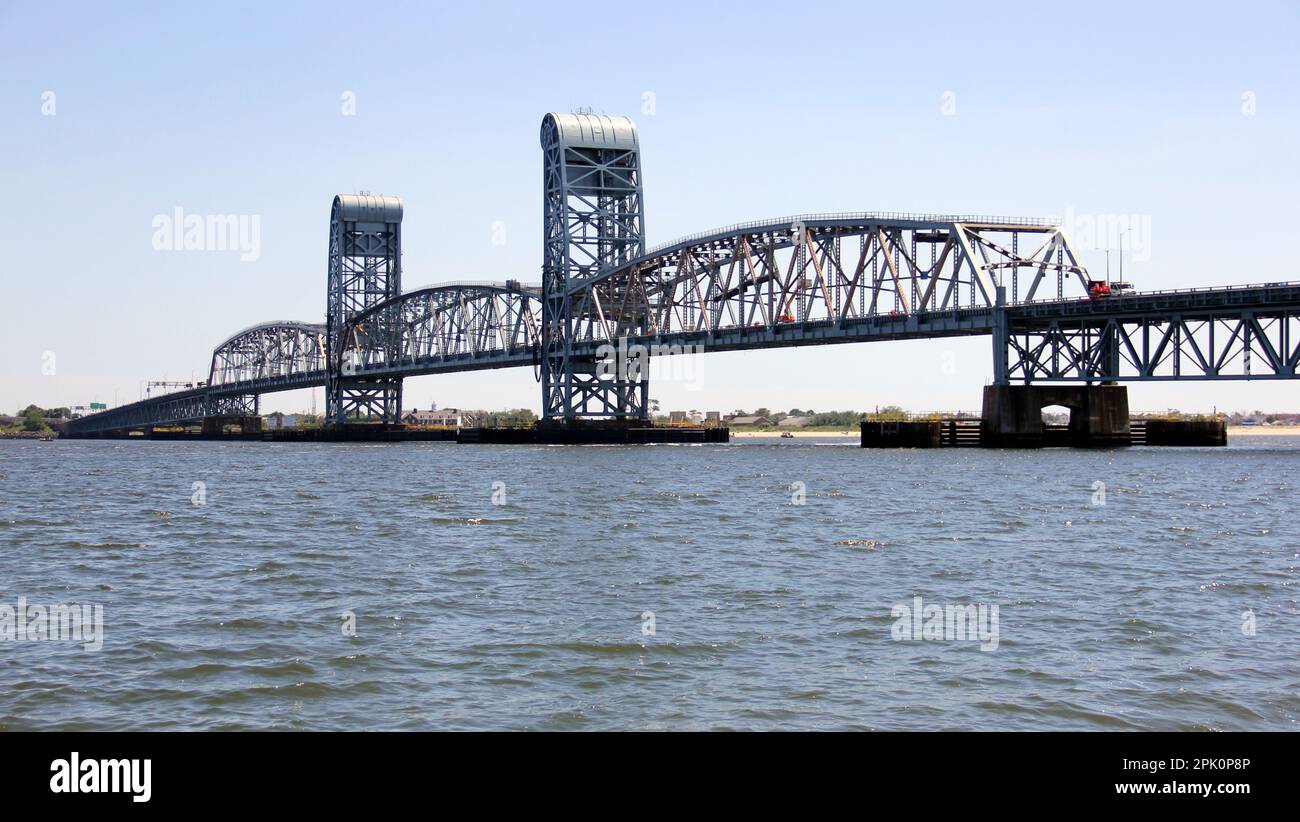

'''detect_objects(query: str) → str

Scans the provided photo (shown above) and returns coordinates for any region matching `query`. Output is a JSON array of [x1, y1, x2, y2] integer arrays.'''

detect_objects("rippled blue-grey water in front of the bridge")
[[0, 437, 1300, 730]]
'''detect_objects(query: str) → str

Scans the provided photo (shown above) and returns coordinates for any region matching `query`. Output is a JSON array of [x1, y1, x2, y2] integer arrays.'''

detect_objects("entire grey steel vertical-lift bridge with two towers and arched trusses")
[[68, 113, 1300, 441]]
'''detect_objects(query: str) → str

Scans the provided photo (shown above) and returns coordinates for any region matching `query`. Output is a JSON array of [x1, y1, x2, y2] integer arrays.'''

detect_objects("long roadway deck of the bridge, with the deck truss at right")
[[70, 282, 1300, 434]]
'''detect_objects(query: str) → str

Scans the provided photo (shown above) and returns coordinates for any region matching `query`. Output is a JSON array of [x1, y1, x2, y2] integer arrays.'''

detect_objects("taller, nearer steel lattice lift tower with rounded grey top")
[[541, 113, 650, 424]]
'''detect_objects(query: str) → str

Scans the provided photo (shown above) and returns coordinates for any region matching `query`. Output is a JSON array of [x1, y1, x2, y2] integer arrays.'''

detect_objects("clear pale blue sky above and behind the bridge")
[[0, 1, 1300, 411]]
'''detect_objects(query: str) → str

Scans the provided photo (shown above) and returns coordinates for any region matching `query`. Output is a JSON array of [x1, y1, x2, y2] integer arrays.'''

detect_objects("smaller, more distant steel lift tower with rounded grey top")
[[325, 194, 402, 425]]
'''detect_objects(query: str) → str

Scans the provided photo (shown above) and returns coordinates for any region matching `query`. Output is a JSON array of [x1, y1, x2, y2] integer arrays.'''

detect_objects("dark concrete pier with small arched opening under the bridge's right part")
[[980, 385, 1130, 447]]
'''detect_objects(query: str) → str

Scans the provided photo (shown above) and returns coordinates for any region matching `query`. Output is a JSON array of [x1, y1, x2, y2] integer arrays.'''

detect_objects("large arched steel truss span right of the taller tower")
[[567, 215, 1088, 343]]
